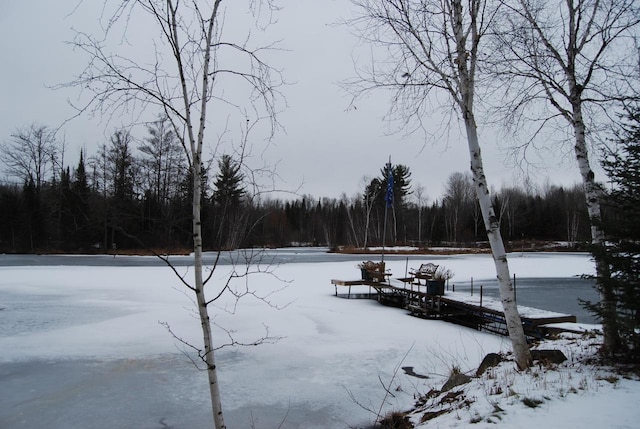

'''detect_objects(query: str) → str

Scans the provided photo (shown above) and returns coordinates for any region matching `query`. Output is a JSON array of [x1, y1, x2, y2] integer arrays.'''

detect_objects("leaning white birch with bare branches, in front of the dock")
[[349, 0, 531, 369]]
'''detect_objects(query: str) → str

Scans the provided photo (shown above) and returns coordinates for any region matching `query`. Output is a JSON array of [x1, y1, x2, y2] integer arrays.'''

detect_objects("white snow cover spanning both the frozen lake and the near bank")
[[0, 249, 640, 429]]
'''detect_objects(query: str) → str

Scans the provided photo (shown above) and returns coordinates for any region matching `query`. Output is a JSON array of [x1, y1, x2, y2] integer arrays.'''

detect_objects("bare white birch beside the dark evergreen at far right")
[[490, 0, 640, 352]]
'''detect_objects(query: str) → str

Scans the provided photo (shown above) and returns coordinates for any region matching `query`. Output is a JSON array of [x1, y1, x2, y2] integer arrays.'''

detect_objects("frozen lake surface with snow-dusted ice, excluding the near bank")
[[0, 249, 632, 429]]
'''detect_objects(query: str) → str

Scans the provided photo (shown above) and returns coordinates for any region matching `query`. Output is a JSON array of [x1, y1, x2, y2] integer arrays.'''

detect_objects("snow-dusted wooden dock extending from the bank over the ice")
[[331, 279, 576, 338]]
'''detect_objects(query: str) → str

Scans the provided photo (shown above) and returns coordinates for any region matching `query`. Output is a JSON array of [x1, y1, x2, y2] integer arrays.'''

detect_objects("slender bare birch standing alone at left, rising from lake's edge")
[[63, 0, 282, 429]]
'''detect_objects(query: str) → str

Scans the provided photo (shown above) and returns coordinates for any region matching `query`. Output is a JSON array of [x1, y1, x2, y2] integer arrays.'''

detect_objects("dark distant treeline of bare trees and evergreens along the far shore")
[[0, 119, 590, 253]]
